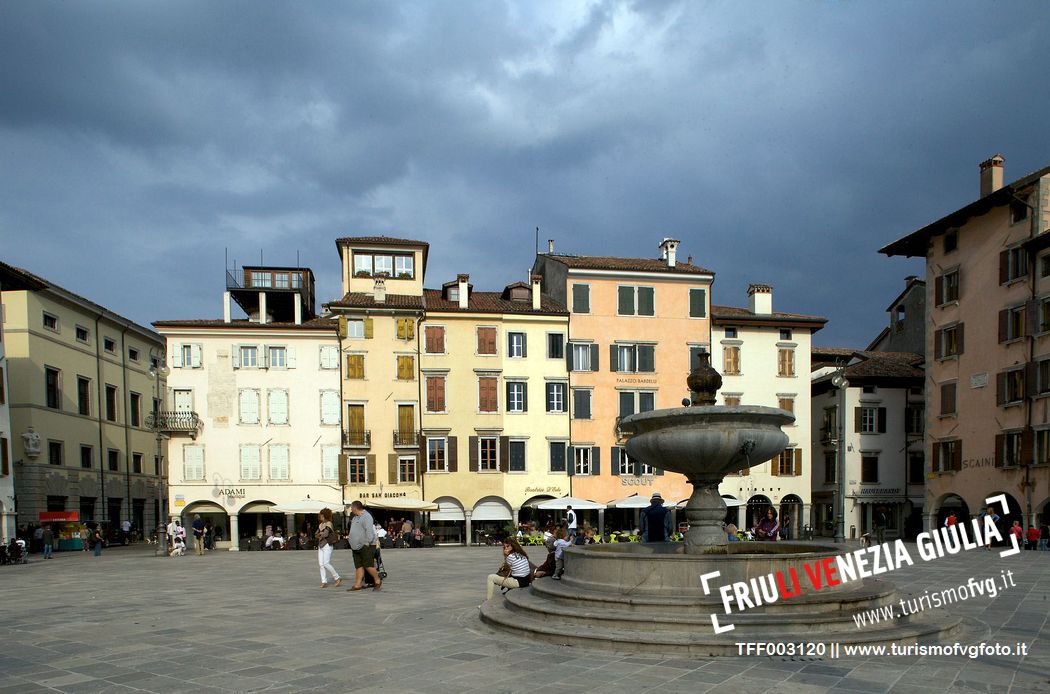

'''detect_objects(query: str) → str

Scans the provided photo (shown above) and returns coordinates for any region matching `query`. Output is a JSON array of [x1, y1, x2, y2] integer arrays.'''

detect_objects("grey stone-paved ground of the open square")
[[0, 546, 1050, 694]]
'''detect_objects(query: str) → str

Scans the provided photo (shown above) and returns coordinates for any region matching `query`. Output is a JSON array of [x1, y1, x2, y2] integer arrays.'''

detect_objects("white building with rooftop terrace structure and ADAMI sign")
[[154, 267, 343, 550]]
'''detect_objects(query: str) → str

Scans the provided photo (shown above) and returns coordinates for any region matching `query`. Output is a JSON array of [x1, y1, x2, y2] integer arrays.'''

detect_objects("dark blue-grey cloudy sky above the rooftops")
[[0, 0, 1050, 348]]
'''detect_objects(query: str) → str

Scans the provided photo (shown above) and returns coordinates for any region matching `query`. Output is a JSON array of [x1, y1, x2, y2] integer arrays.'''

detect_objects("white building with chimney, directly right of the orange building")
[[713, 285, 827, 538]]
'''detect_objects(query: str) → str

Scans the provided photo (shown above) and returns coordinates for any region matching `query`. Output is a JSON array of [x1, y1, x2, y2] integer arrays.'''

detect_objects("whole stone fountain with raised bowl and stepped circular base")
[[481, 353, 966, 655]]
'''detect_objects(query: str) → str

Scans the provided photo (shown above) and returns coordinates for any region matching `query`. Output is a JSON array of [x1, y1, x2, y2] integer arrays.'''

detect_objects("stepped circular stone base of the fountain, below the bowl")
[[481, 543, 963, 656]]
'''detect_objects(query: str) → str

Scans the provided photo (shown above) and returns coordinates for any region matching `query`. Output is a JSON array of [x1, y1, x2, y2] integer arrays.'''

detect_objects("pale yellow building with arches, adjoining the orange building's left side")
[[420, 274, 569, 542]]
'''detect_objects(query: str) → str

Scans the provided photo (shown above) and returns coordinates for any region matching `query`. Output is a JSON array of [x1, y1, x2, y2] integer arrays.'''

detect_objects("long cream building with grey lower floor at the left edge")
[[0, 264, 166, 535]]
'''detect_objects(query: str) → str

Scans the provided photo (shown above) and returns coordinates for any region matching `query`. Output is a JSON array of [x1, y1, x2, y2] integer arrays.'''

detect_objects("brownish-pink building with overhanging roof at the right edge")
[[881, 155, 1050, 527]]
